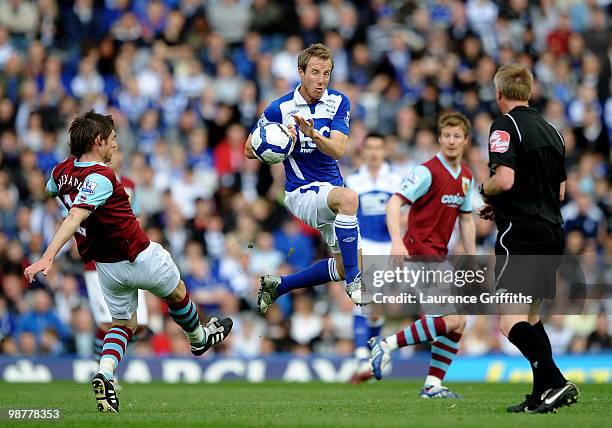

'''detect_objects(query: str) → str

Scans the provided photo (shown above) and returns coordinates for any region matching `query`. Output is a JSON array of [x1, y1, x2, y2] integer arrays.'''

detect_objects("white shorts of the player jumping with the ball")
[[285, 181, 361, 253]]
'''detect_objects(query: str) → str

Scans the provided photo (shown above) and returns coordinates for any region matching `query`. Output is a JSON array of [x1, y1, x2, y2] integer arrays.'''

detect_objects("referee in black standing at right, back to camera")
[[479, 64, 579, 413]]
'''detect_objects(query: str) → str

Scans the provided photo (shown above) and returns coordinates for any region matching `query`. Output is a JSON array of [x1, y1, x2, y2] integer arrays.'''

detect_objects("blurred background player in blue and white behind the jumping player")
[[346, 133, 402, 383]]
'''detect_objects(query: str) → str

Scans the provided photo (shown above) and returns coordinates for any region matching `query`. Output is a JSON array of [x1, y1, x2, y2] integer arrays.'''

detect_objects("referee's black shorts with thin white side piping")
[[495, 221, 565, 299]]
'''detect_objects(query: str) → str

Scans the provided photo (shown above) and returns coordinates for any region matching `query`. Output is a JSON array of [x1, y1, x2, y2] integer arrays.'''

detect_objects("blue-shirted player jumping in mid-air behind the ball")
[[245, 43, 372, 313]]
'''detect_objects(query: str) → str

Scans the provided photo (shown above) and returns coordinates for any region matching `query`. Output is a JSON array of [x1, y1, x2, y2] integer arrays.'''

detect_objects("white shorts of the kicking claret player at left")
[[96, 241, 181, 320]]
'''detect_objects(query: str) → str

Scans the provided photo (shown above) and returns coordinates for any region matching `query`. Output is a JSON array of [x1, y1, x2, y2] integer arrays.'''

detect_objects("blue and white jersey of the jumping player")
[[257, 86, 351, 192]]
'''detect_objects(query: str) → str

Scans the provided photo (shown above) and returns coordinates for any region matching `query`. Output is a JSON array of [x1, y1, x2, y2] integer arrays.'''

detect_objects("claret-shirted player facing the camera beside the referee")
[[371, 113, 476, 398]]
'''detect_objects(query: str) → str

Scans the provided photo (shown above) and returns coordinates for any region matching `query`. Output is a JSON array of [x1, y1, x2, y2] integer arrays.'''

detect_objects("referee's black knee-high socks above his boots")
[[508, 321, 565, 400]]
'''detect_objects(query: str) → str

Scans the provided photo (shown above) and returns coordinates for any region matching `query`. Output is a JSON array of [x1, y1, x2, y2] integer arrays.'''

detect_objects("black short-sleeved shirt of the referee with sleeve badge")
[[489, 106, 567, 230]]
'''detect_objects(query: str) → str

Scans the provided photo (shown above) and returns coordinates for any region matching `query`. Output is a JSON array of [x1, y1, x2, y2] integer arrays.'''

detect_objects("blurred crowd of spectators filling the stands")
[[0, 0, 612, 362]]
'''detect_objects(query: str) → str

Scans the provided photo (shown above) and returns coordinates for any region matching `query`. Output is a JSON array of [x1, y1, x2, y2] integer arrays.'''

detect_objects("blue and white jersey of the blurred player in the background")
[[346, 162, 402, 242]]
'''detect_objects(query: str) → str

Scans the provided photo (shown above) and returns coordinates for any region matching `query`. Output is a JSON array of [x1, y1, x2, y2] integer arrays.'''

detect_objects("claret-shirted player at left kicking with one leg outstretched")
[[24, 111, 232, 412]]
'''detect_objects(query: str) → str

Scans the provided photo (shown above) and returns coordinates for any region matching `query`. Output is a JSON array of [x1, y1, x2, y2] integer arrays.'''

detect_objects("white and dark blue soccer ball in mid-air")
[[251, 123, 294, 164]]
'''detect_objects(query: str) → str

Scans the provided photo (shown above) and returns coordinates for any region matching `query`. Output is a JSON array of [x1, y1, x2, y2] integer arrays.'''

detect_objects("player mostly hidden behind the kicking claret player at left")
[[82, 146, 149, 364]]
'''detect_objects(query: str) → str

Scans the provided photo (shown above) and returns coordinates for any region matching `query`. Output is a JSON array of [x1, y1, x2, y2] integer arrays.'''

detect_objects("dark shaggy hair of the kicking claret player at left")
[[69, 110, 115, 158]]
